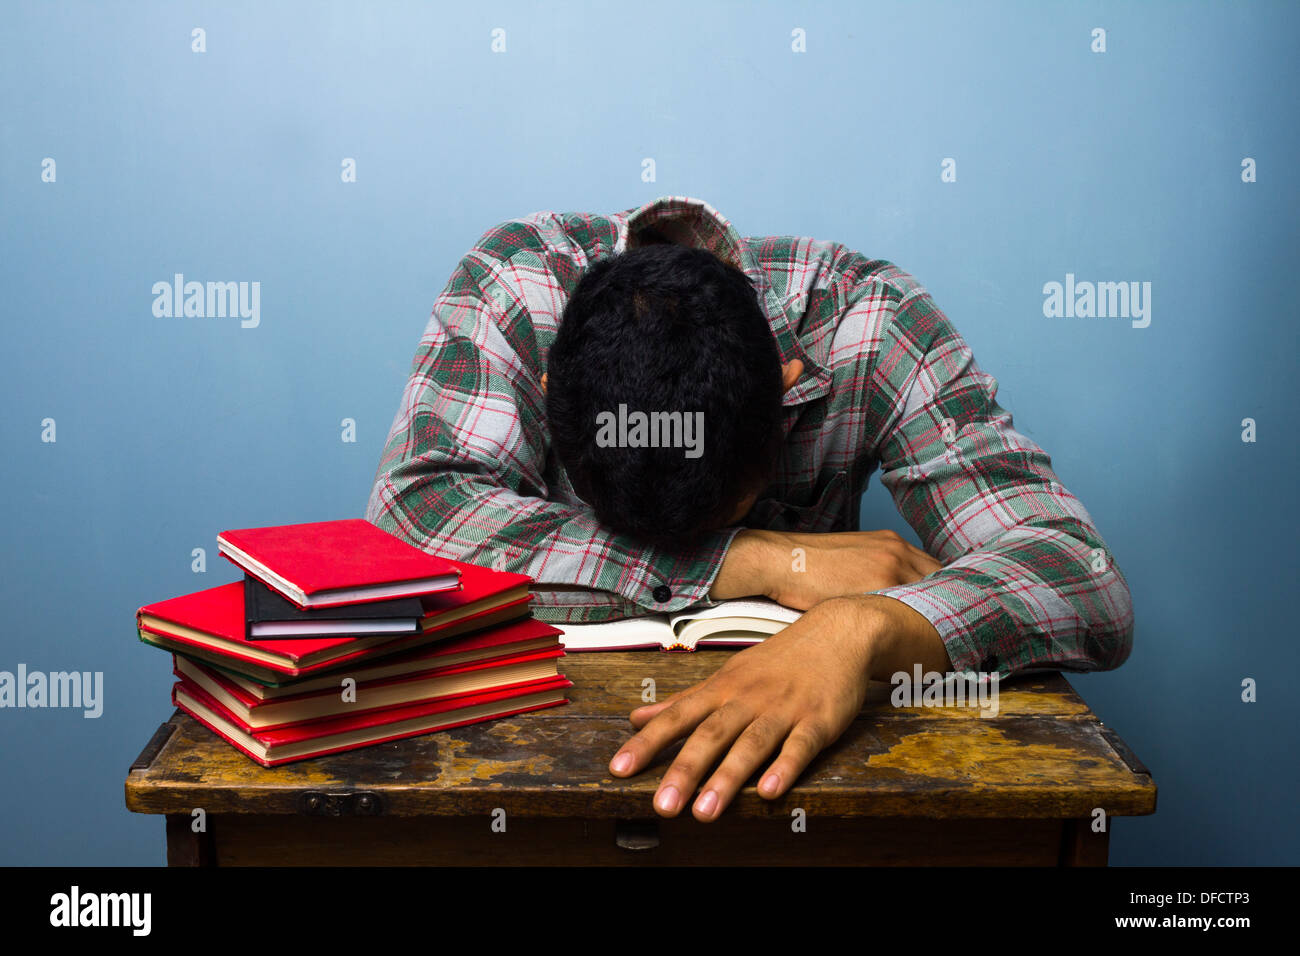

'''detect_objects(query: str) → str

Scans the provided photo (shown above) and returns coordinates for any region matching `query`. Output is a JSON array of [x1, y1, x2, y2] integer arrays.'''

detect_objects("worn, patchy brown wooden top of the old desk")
[[126, 650, 1156, 818]]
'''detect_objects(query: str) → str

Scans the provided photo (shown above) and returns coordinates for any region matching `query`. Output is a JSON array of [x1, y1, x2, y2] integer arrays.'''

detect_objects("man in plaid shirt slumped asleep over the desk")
[[367, 196, 1132, 822]]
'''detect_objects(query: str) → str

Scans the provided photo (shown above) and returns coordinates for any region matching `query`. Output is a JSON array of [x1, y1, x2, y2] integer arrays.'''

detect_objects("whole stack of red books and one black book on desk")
[[137, 519, 572, 766]]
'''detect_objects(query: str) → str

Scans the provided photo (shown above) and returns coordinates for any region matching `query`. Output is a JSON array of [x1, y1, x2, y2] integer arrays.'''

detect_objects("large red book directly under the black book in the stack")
[[137, 562, 532, 684]]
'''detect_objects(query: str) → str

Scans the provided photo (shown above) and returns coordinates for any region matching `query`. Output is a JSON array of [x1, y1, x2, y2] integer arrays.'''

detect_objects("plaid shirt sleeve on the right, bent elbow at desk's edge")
[[871, 286, 1134, 676]]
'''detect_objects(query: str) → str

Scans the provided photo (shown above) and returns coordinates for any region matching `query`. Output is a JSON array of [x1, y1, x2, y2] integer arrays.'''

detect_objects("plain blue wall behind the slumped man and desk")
[[0, 0, 1300, 864]]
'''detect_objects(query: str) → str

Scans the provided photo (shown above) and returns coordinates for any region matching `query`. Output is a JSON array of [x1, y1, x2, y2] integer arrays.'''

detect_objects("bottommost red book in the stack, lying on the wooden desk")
[[172, 676, 573, 767]]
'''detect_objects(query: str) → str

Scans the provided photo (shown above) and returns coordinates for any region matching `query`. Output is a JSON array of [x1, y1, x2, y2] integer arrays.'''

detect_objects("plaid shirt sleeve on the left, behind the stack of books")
[[365, 244, 738, 623]]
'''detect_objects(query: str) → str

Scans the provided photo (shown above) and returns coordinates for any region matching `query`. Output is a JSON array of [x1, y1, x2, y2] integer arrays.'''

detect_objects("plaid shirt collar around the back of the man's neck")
[[614, 196, 831, 406]]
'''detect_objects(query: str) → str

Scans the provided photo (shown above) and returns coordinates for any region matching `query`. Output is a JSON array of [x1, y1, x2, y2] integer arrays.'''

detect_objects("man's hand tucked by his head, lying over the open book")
[[709, 529, 943, 611]]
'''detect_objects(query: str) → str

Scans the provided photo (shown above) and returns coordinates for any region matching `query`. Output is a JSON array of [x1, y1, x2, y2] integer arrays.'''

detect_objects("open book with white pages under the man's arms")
[[555, 598, 802, 652]]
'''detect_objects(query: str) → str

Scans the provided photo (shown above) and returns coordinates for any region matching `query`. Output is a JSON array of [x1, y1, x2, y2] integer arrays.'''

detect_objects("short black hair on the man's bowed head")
[[546, 243, 784, 545]]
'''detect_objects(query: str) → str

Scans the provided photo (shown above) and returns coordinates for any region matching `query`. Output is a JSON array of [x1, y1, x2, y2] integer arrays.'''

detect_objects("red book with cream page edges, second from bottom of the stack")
[[173, 644, 564, 731]]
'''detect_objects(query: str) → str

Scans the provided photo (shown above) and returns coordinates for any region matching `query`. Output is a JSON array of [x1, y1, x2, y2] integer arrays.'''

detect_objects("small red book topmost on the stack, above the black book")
[[217, 518, 459, 609]]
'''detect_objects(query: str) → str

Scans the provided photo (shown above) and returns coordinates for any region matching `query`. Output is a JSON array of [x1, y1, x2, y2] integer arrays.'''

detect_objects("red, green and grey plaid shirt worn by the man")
[[367, 196, 1132, 676]]
